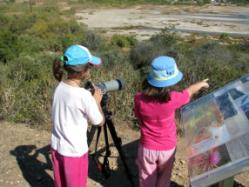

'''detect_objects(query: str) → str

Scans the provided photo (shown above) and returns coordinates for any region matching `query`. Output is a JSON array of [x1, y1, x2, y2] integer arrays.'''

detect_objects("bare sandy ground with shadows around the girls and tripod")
[[0, 122, 249, 187]]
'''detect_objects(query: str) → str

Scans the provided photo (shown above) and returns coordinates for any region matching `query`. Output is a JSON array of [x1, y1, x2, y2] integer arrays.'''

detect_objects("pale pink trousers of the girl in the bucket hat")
[[137, 145, 175, 187]]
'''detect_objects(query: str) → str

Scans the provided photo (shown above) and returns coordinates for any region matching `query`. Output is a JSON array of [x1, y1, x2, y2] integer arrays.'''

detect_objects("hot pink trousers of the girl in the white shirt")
[[51, 149, 88, 187]]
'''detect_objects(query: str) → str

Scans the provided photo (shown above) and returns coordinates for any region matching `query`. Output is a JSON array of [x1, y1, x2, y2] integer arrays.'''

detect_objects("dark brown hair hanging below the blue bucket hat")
[[142, 79, 170, 102]]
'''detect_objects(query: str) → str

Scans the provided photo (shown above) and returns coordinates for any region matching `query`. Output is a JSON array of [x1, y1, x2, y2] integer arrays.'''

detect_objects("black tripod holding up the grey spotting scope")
[[88, 94, 135, 187]]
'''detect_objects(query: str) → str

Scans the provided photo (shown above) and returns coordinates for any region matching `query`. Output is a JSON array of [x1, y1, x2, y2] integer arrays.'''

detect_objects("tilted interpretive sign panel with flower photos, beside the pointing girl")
[[181, 75, 249, 187]]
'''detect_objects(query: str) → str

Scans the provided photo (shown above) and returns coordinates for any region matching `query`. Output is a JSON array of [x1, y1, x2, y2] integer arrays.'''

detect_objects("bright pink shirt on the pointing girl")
[[134, 89, 190, 150]]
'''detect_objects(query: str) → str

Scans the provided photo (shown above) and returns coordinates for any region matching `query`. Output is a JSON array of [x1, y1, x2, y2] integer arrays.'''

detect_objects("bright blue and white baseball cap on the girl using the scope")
[[63, 45, 101, 66]]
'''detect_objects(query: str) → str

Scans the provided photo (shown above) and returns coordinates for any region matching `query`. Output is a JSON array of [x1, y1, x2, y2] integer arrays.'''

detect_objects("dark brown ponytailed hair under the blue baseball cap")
[[53, 59, 92, 81]]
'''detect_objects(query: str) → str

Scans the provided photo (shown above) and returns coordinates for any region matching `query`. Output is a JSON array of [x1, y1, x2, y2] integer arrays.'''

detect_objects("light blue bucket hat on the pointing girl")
[[147, 56, 183, 88]]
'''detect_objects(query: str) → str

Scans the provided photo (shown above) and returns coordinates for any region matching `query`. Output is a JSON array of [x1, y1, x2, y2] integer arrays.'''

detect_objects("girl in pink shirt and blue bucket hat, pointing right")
[[134, 56, 209, 187]]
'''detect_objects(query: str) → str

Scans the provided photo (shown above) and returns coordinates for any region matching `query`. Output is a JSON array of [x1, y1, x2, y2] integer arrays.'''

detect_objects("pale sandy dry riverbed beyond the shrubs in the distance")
[[76, 5, 249, 40]]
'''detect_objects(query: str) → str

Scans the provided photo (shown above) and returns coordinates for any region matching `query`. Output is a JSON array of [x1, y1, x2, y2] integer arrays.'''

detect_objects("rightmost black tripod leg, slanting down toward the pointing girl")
[[106, 117, 135, 187]]
